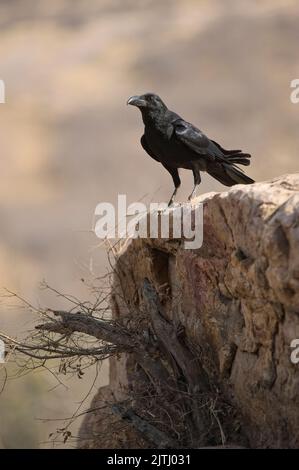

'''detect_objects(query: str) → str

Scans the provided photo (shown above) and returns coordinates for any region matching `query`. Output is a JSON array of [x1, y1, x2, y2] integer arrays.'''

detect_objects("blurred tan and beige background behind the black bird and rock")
[[0, 0, 299, 448]]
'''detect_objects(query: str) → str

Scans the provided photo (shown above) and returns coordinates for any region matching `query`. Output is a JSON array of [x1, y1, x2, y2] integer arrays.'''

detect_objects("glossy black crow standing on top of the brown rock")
[[127, 93, 254, 205]]
